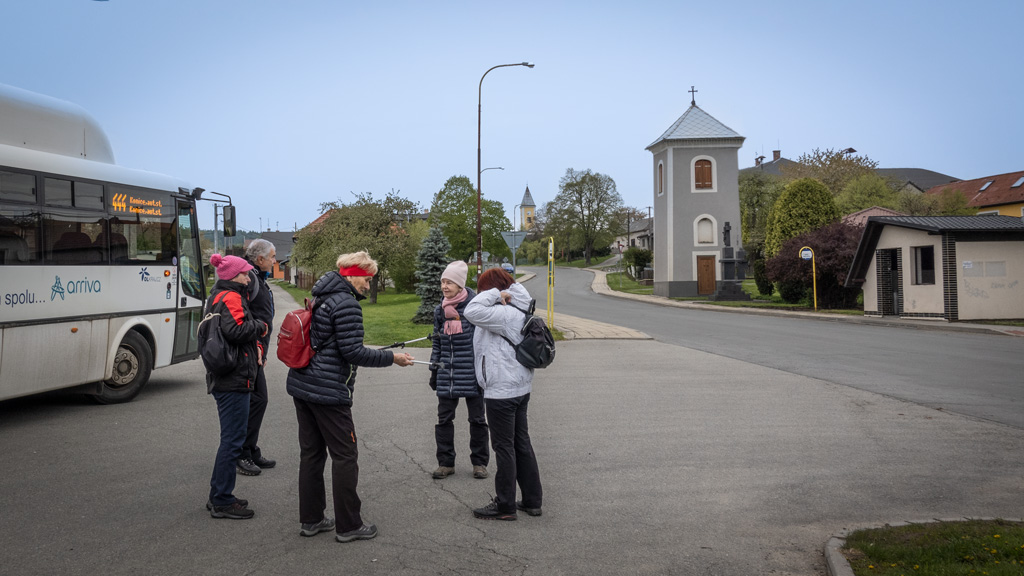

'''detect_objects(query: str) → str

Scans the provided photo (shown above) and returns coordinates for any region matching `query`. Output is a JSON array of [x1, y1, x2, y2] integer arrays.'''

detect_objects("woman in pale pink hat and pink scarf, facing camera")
[[430, 260, 490, 480]]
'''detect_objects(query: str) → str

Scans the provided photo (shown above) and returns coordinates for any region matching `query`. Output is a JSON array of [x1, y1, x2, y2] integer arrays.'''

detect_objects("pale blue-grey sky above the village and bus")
[[0, 0, 1024, 230]]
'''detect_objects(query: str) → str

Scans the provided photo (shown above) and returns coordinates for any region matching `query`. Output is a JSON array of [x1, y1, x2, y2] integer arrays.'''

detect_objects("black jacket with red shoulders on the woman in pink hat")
[[206, 280, 266, 392]]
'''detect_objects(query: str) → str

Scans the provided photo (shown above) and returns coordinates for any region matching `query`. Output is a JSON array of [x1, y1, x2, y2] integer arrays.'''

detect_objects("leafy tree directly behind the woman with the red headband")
[[293, 191, 417, 303]]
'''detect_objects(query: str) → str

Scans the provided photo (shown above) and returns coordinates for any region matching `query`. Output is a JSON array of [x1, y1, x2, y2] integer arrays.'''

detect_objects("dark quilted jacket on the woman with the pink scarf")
[[430, 288, 483, 398]]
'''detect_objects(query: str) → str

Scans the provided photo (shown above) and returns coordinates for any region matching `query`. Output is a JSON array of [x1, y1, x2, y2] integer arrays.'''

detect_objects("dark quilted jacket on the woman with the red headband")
[[288, 271, 394, 406]]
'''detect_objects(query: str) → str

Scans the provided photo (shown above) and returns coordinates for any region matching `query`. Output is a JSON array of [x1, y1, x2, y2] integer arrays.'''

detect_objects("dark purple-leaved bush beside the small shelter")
[[766, 221, 861, 308]]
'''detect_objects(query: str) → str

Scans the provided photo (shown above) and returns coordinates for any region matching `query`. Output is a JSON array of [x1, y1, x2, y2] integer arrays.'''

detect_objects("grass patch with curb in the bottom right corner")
[[843, 520, 1024, 576]]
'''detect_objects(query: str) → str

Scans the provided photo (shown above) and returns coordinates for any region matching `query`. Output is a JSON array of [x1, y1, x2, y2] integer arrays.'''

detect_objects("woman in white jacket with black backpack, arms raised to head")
[[464, 269, 544, 520]]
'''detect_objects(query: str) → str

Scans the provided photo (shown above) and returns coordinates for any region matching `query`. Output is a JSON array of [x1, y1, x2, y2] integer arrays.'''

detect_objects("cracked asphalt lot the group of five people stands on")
[[0, 282, 1024, 576]]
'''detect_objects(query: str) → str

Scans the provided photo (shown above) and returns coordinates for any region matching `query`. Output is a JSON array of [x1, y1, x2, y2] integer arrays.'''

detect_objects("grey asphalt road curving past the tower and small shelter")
[[524, 269, 1024, 428]]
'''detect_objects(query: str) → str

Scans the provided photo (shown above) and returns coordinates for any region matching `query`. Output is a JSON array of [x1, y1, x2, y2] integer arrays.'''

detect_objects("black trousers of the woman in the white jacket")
[[484, 394, 544, 512]]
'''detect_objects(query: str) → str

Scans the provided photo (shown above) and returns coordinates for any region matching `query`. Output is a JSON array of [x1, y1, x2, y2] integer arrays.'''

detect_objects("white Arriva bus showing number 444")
[[0, 84, 214, 404]]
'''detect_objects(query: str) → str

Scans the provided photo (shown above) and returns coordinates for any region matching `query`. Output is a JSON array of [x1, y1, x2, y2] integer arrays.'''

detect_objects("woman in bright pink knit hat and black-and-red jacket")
[[206, 254, 268, 520]]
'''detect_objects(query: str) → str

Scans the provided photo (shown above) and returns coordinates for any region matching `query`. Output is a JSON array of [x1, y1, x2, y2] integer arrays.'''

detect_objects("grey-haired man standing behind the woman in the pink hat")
[[238, 238, 278, 476]]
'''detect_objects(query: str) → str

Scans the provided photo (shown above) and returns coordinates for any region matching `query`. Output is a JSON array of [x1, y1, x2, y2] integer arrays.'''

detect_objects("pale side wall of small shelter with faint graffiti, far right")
[[956, 237, 1024, 320]]
